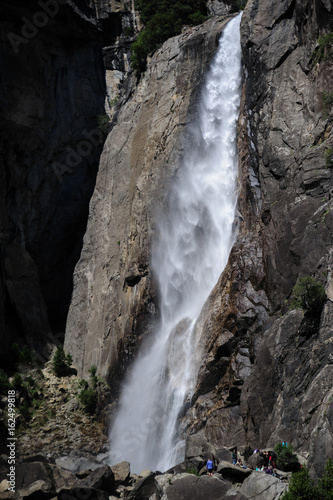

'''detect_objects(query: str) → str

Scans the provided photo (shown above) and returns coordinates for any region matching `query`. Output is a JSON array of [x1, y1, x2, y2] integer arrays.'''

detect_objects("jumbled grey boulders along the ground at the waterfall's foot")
[[0, 449, 287, 500]]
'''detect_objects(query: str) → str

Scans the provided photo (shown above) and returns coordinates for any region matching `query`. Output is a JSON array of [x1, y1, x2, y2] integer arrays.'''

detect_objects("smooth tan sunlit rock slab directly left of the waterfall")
[[65, 17, 232, 379]]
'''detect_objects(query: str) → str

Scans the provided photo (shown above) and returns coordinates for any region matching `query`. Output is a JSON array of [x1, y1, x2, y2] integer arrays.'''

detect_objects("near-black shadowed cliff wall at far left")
[[0, 0, 105, 360]]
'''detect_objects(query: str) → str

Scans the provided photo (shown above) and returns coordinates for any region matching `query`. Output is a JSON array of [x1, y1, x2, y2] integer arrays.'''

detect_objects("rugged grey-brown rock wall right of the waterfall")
[[184, 0, 333, 475]]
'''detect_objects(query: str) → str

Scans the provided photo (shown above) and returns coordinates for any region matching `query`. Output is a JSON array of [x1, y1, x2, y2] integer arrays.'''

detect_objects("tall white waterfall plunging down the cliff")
[[110, 15, 241, 474]]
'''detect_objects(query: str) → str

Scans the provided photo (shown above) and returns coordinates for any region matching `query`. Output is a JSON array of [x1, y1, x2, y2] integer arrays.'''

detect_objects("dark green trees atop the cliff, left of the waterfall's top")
[[131, 0, 207, 75]]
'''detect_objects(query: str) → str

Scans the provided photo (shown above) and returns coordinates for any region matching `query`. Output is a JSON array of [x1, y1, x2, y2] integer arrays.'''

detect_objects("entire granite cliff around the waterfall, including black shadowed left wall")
[[0, 0, 333, 484]]
